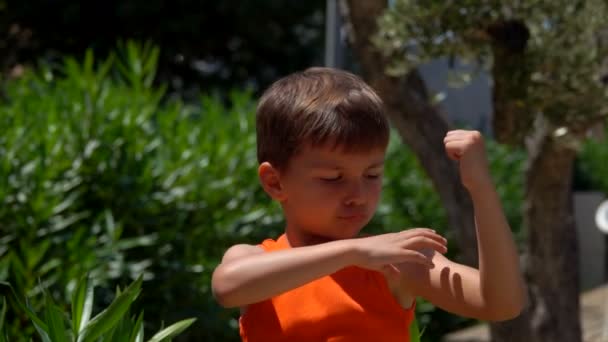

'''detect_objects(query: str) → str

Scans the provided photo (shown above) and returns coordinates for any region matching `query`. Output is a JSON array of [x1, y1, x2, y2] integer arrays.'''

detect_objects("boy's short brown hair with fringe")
[[256, 67, 389, 169]]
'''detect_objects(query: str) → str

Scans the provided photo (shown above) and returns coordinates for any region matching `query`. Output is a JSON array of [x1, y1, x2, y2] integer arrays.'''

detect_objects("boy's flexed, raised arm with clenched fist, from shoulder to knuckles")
[[399, 131, 527, 321]]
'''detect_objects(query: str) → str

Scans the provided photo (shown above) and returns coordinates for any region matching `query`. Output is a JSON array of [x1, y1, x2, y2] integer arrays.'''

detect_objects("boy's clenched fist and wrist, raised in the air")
[[443, 130, 491, 191]]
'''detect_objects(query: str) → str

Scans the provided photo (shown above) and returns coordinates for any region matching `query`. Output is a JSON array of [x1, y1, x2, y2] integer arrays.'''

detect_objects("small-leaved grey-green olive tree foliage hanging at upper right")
[[375, 0, 608, 136]]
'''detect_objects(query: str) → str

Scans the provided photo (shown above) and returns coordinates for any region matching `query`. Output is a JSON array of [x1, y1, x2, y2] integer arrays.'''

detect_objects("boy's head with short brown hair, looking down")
[[257, 68, 389, 240]]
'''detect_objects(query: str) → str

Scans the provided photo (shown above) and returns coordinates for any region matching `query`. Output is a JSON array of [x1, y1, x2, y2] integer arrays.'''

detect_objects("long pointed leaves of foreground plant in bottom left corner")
[[0, 276, 195, 342]]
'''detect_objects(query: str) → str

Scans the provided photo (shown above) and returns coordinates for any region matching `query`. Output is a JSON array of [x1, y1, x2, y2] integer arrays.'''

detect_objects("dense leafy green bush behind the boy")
[[0, 43, 521, 341]]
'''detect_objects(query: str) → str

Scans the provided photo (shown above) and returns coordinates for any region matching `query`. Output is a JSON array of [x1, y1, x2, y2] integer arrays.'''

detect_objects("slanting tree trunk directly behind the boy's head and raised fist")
[[341, 0, 477, 266]]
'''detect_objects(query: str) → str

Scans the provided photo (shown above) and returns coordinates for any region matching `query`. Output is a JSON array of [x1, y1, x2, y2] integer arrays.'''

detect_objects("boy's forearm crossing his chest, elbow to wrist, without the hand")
[[212, 240, 355, 307]]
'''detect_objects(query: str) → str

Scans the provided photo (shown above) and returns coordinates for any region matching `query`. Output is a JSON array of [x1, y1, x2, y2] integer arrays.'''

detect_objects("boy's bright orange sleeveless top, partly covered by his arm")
[[239, 234, 414, 342]]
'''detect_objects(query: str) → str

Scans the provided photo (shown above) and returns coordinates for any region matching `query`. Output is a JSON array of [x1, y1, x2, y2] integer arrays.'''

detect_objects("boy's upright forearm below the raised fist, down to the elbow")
[[469, 182, 527, 314]]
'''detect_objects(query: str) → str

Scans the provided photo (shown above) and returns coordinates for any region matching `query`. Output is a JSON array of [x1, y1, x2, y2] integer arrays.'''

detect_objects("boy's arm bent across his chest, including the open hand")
[[212, 228, 446, 307]]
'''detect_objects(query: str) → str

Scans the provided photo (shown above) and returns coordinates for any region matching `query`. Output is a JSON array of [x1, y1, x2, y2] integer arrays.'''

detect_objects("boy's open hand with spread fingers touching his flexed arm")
[[350, 228, 447, 271]]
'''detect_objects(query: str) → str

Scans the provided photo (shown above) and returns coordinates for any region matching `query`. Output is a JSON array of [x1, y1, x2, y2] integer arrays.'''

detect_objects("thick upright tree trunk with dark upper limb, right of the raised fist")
[[487, 21, 582, 342]]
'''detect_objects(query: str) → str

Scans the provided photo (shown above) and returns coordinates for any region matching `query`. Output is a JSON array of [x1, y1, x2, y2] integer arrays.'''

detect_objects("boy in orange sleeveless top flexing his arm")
[[212, 68, 526, 342]]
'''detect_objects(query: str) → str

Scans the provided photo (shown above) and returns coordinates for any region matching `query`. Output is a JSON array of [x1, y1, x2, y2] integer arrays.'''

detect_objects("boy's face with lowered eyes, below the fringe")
[[280, 147, 385, 240]]
